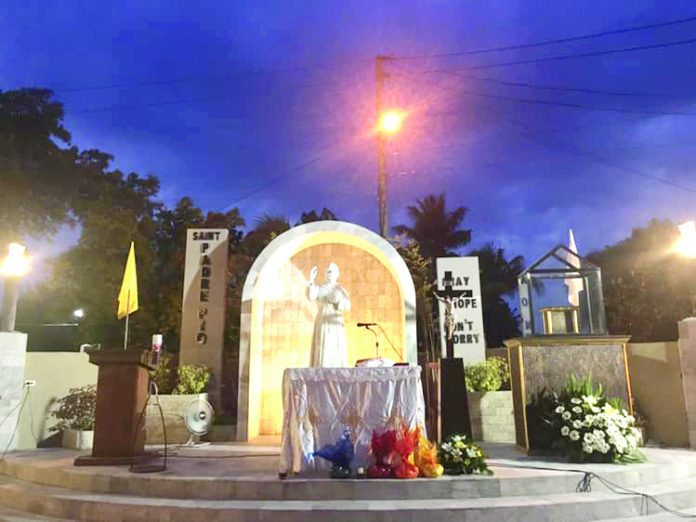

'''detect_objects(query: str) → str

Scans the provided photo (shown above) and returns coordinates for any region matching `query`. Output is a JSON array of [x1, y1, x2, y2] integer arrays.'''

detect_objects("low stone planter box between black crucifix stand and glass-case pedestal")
[[468, 391, 515, 442]]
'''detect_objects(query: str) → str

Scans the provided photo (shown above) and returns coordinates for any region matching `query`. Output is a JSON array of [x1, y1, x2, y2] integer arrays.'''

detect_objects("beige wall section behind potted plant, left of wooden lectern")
[[17, 352, 97, 449]]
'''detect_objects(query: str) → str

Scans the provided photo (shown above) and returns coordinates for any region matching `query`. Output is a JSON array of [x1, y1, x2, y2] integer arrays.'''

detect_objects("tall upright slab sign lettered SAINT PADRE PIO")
[[179, 228, 229, 406]]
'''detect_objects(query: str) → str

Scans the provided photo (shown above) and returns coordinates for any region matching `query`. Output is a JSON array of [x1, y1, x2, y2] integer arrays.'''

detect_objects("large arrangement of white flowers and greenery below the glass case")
[[550, 377, 645, 463]]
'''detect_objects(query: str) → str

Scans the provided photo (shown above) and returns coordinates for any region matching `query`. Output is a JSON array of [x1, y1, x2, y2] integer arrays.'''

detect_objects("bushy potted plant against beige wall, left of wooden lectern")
[[49, 384, 97, 450]]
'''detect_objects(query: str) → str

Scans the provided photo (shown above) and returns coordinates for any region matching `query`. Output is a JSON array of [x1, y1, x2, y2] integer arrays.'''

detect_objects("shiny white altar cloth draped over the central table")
[[279, 366, 425, 473]]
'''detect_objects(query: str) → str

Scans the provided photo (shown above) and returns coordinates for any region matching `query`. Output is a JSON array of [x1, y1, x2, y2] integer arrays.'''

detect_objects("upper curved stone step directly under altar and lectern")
[[0, 450, 696, 501]]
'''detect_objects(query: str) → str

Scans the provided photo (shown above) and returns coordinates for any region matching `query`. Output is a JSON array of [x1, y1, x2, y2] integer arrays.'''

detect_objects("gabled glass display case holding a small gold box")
[[517, 245, 607, 337]]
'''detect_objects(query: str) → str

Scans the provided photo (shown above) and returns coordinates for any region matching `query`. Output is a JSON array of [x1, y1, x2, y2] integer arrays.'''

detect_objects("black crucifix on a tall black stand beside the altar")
[[434, 271, 471, 440]]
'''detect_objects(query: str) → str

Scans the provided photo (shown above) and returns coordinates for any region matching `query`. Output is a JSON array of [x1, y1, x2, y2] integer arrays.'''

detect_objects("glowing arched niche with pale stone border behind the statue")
[[237, 221, 418, 440]]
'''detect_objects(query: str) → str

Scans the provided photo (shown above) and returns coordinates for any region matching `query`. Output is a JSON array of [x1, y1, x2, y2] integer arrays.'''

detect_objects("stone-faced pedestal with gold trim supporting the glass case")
[[505, 335, 633, 451]]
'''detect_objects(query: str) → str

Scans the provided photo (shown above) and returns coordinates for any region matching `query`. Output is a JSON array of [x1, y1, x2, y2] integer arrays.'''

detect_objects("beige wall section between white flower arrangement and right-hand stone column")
[[628, 342, 688, 447]]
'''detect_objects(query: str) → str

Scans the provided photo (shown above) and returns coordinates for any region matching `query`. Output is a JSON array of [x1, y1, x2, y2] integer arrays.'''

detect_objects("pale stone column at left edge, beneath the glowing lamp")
[[0, 332, 27, 453]]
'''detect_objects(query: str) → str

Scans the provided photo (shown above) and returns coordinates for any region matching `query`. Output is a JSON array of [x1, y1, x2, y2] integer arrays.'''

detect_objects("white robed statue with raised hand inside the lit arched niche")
[[307, 263, 350, 368]]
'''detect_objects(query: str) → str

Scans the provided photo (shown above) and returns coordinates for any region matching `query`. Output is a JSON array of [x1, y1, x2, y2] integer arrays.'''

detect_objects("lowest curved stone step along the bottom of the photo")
[[0, 477, 696, 522]]
